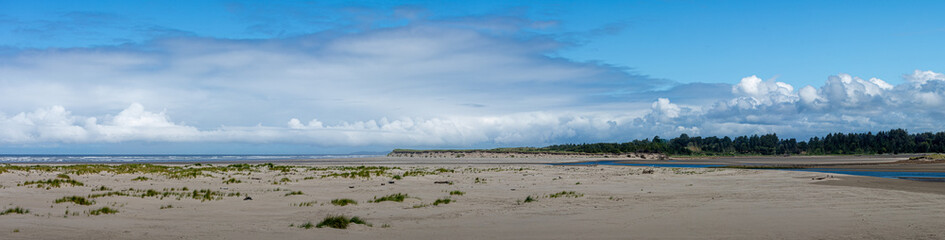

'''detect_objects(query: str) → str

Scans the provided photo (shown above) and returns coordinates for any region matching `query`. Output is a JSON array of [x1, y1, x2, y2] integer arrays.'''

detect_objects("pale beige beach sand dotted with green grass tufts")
[[0, 159, 945, 239]]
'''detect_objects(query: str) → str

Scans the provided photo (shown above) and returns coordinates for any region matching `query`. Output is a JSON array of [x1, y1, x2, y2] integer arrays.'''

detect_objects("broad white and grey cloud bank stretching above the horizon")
[[0, 12, 945, 152]]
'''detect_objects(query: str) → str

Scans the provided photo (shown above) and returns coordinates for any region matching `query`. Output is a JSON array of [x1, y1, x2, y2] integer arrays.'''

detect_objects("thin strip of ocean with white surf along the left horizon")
[[0, 154, 382, 163]]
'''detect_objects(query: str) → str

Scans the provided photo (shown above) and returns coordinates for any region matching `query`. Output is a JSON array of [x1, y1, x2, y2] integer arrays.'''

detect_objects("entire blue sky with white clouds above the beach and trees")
[[0, 0, 945, 154]]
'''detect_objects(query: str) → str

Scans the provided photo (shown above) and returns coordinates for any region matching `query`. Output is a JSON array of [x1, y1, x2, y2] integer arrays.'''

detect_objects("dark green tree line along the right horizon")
[[541, 129, 945, 155]]
